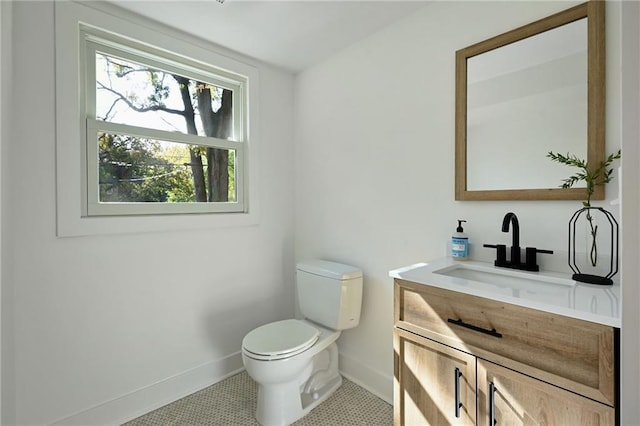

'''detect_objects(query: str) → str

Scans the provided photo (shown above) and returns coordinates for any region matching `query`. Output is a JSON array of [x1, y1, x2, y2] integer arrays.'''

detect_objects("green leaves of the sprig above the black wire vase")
[[547, 150, 622, 207]]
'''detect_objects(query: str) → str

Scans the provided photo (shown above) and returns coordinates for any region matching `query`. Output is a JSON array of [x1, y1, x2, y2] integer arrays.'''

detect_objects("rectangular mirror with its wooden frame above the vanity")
[[455, 0, 605, 201]]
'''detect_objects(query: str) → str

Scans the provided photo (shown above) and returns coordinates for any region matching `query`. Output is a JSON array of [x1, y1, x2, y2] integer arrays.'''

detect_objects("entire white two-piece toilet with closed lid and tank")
[[242, 260, 362, 426]]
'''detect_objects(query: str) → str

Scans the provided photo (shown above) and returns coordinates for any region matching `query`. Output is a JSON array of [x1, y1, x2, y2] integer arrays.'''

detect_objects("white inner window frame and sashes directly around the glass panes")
[[80, 25, 248, 216]]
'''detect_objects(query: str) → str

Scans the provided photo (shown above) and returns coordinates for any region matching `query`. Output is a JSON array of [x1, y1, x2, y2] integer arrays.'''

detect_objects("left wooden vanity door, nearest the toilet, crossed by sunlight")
[[394, 329, 476, 426]]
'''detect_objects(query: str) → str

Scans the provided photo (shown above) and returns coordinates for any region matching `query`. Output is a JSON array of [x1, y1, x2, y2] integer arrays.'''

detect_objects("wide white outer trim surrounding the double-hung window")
[[53, 1, 264, 237]]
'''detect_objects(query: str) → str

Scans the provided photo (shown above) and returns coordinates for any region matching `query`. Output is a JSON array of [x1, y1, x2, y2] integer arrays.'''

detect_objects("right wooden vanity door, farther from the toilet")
[[477, 359, 615, 426]]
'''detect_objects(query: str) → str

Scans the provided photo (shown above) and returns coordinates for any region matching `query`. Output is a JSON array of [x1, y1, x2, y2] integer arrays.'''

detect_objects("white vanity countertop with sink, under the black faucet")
[[389, 257, 622, 328]]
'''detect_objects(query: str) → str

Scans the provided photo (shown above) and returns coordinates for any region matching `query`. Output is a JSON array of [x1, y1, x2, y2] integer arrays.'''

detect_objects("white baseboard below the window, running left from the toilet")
[[51, 352, 244, 426]]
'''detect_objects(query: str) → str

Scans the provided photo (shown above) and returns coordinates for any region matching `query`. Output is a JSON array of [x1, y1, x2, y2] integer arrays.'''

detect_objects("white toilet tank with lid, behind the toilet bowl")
[[296, 260, 362, 330]]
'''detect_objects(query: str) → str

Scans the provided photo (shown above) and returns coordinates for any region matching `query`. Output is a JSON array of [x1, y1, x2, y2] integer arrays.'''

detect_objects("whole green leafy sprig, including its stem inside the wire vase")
[[547, 150, 622, 267]]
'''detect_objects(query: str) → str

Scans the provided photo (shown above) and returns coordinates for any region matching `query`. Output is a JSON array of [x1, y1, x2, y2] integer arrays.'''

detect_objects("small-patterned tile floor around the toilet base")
[[124, 372, 393, 426]]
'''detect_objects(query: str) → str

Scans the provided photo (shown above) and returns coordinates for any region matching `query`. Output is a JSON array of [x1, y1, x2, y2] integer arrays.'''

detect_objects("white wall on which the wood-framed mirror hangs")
[[294, 2, 624, 401]]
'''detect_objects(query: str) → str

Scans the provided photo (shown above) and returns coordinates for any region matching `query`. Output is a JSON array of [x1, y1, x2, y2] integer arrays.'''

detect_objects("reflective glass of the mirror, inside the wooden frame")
[[467, 18, 587, 191]]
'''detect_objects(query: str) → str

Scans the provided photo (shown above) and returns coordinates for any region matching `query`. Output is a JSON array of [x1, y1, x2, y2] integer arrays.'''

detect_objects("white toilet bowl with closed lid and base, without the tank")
[[242, 319, 342, 426]]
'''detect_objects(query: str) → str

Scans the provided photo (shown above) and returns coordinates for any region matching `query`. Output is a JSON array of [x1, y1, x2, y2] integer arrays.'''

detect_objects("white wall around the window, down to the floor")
[[2, 2, 294, 425]]
